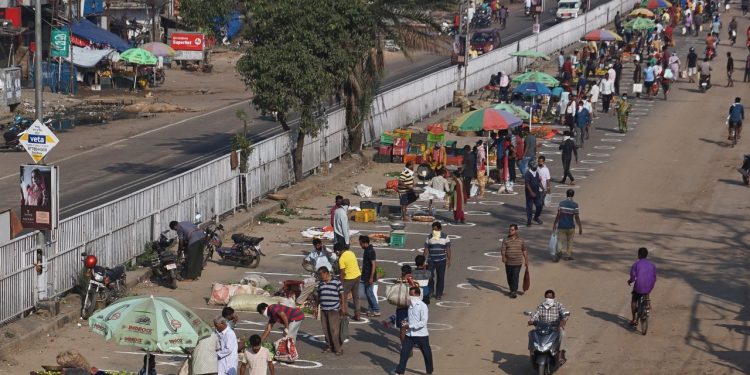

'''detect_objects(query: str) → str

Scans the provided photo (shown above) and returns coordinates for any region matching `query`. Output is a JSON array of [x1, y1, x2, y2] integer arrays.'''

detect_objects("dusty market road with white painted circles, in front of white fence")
[[5, 13, 750, 375]]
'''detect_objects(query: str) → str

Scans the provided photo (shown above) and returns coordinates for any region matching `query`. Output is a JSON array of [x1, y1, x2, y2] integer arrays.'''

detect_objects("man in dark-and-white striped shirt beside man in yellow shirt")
[[318, 267, 347, 355]]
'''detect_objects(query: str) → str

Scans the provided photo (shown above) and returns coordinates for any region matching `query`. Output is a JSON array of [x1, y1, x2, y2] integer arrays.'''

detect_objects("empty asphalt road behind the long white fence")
[[0, 0, 624, 218]]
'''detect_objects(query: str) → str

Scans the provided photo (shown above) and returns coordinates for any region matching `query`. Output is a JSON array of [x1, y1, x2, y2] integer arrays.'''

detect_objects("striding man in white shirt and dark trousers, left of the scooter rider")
[[394, 287, 434, 375]]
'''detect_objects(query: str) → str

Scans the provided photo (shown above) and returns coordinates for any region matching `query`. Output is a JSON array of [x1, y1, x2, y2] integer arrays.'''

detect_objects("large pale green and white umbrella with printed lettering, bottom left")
[[89, 296, 212, 353]]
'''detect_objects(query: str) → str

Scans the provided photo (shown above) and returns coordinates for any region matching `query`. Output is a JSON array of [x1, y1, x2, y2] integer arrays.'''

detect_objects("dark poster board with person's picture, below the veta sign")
[[20, 164, 58, 230]]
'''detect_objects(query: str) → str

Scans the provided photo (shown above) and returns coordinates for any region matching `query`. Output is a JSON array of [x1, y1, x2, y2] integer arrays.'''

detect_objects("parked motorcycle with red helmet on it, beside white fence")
[[81, 253, 127, 319]]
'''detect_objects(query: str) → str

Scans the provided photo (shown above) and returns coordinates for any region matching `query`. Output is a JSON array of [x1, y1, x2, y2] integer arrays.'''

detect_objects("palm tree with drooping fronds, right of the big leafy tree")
[[342, 0, 455, 153]]
